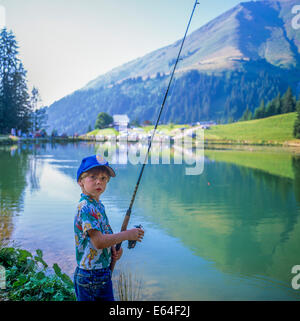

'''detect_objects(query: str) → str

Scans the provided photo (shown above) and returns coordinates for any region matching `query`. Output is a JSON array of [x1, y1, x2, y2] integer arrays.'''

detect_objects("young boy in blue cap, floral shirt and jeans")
[[74, 155, 144, 301]]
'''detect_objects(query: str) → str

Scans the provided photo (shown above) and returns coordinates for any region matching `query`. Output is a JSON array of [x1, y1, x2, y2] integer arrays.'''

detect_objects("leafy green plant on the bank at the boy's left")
[[0, 247, 75, 301]]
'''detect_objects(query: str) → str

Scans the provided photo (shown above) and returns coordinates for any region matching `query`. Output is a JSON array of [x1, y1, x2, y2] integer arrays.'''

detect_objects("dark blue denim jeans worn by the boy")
[[74, 267, 114, 301]]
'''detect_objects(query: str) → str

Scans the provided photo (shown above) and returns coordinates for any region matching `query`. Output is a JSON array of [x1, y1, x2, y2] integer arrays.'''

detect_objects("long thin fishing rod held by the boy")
[[110, 0, 200, 271]]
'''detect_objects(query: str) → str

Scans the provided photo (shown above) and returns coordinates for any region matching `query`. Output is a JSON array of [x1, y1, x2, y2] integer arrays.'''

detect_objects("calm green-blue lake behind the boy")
[[0, 142, 300, 300]]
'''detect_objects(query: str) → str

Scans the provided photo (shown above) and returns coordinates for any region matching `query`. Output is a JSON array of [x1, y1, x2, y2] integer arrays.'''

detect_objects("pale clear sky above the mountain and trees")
[[0, 0, 245, 106]]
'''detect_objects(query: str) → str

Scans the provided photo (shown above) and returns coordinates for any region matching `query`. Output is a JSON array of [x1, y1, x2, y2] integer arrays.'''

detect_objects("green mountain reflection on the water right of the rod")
[[115, 164, 300, 282]]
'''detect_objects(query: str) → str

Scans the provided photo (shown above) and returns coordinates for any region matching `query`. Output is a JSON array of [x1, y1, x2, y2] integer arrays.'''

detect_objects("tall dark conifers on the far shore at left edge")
[[0, 28, 47, 134]]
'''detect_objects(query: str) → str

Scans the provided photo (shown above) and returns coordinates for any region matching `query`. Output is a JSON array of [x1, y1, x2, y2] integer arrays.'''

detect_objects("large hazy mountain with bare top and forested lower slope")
[[48, 0, 300, 134]]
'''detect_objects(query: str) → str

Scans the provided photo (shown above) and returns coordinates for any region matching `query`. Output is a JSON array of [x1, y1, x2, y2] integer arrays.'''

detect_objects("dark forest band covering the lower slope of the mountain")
[[48, 62, 297, 134]]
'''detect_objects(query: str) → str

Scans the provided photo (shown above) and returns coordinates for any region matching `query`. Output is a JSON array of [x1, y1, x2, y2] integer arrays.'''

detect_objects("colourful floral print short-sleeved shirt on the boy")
[[74, 193, 113, 270]]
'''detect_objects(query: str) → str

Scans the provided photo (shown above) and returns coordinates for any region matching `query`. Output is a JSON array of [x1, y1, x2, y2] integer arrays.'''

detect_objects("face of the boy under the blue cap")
[[78, 168, 110, 201]]
